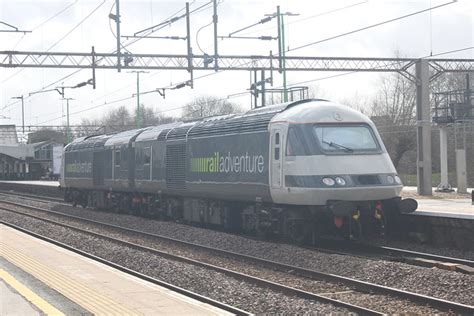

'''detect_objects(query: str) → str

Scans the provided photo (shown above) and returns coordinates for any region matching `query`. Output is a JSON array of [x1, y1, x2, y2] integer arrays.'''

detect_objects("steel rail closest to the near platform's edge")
[[0, 220, 253, 315]]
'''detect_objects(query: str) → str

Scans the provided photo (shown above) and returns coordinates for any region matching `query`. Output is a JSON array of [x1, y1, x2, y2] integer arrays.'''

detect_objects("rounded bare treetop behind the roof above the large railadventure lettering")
[[182, 96, 241, 119]]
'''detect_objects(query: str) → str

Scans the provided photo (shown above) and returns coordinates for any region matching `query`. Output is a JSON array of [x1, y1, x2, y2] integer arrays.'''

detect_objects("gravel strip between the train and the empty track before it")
[[1, 196, 474, 305]]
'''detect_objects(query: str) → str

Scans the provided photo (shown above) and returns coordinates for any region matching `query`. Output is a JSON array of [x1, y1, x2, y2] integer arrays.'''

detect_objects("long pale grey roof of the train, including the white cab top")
[[66, 99, 352, 150]]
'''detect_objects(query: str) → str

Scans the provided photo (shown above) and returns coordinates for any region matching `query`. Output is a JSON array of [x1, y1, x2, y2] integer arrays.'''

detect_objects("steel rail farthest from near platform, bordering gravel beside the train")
[[1, 201, 474, 314]]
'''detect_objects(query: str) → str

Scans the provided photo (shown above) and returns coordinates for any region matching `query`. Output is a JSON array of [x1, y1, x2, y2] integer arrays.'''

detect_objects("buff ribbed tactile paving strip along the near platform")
[[0, 242, 142, 315]]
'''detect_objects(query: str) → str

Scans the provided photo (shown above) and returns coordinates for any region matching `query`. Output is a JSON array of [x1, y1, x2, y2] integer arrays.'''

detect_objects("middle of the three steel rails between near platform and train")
[[0, 205, 385, 315]]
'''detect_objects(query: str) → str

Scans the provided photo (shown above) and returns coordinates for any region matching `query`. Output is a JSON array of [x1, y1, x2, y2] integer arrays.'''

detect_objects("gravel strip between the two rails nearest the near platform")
[[0, 211, 349, 314]]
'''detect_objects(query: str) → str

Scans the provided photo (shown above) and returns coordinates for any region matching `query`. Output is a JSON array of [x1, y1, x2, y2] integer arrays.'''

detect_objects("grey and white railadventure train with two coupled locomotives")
[[60, 99, 417, 242]]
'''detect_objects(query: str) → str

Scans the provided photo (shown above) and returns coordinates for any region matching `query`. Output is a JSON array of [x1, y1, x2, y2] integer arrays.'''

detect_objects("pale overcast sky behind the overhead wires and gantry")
[[0, 0, 474, 134]]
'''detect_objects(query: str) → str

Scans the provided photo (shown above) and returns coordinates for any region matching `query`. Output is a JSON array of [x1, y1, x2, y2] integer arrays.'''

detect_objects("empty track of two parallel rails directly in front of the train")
[[2, 202, 474, 314]]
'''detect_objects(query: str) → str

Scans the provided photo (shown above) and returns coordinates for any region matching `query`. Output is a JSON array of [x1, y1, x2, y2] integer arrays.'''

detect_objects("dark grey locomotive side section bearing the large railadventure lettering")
[[186, 111, 276, 203]]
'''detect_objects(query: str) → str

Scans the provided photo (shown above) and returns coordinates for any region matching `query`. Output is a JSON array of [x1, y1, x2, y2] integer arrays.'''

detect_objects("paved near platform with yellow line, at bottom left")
[[0, 225, 230, 315]]
